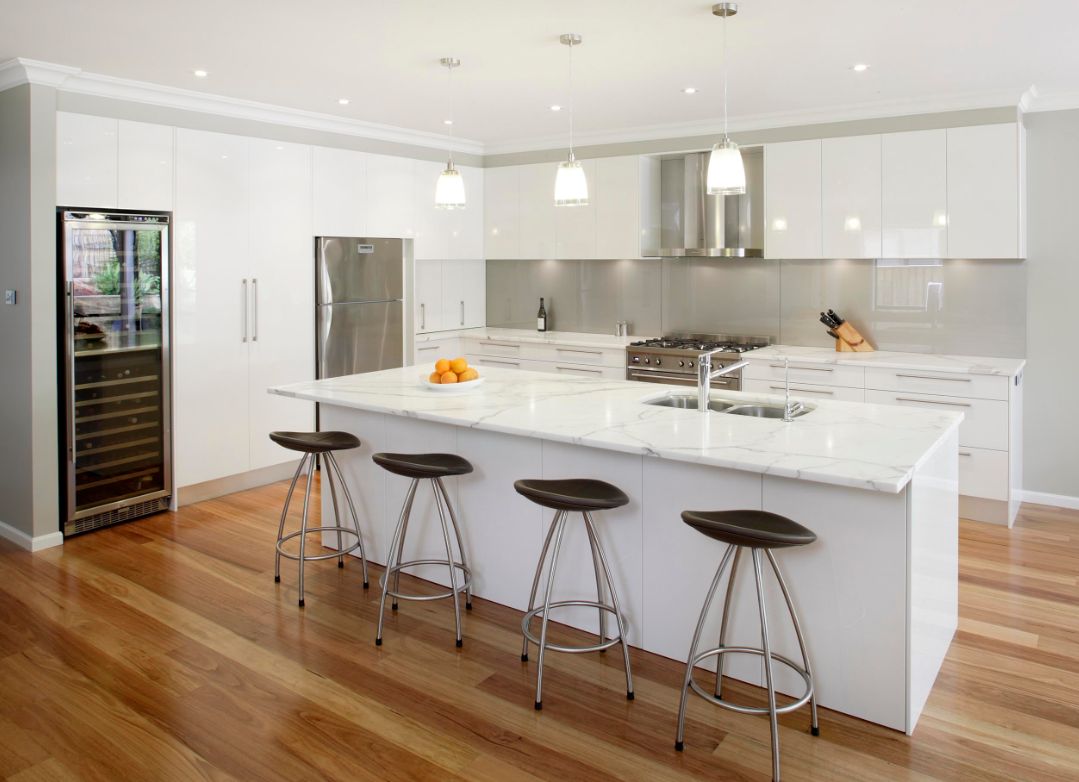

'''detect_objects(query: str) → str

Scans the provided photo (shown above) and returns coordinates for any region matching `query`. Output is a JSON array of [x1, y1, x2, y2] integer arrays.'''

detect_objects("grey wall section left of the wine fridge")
[[0, 85, 59, 536]]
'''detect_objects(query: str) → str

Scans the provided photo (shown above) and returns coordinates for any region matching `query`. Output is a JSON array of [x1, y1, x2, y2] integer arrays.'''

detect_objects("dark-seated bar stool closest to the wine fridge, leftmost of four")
[[270, 431, 368, 608]]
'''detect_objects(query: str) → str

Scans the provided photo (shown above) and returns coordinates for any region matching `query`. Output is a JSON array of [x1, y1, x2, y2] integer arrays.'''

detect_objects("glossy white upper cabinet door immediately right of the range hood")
[[764, 139, 823, 259]]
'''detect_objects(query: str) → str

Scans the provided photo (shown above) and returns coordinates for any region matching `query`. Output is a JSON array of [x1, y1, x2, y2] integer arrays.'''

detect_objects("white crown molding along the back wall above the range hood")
[[484, 90, 1021, 155]]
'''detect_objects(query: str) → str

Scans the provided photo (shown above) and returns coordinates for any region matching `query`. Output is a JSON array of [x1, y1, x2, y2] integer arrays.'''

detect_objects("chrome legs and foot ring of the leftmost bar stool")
[[273, 451, 369, 608]]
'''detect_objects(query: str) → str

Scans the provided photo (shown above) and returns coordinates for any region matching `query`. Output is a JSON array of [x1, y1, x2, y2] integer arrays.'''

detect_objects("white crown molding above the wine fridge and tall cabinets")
[[0, 58, 484, 155]]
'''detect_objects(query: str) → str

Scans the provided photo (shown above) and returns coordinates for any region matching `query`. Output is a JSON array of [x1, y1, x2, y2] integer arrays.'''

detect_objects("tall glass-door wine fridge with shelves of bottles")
[[57, 208, 173, 535]]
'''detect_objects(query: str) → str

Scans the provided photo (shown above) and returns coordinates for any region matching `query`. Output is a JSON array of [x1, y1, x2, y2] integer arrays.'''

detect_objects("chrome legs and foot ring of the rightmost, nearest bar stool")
[[674, 544, 820, 782]]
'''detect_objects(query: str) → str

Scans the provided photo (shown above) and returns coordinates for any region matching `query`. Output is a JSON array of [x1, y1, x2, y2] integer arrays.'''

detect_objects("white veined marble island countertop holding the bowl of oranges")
[[270, 367, 962, 493]]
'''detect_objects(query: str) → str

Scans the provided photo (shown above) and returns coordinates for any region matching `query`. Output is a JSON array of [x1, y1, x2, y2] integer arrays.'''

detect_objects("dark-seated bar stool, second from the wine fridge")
[[371, 453, 473, 647]]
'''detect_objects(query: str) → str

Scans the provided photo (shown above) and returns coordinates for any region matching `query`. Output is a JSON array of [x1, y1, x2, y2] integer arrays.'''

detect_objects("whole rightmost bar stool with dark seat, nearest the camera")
[[674, 510, 820, 782]]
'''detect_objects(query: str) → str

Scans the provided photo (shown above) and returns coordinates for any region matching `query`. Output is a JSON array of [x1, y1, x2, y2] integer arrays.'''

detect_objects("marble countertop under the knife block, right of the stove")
[[743, 345, 1026, 378]]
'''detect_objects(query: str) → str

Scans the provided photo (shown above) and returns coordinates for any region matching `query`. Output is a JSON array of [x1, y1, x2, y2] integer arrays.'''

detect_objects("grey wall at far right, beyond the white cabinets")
[[1023, 111, 1079, 497]]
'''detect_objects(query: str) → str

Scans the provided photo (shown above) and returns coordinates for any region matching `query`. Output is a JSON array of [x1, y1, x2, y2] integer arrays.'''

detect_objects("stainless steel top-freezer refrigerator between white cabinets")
[[315, 236, 412, 378]]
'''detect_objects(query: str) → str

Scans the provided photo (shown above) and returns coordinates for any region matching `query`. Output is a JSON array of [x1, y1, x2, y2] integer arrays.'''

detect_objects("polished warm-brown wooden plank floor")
[[0, 484, 1079, 782]]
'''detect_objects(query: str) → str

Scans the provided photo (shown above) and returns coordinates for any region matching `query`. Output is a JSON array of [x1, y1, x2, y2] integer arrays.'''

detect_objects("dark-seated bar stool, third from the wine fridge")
[[514, 479, 633, 710]]
